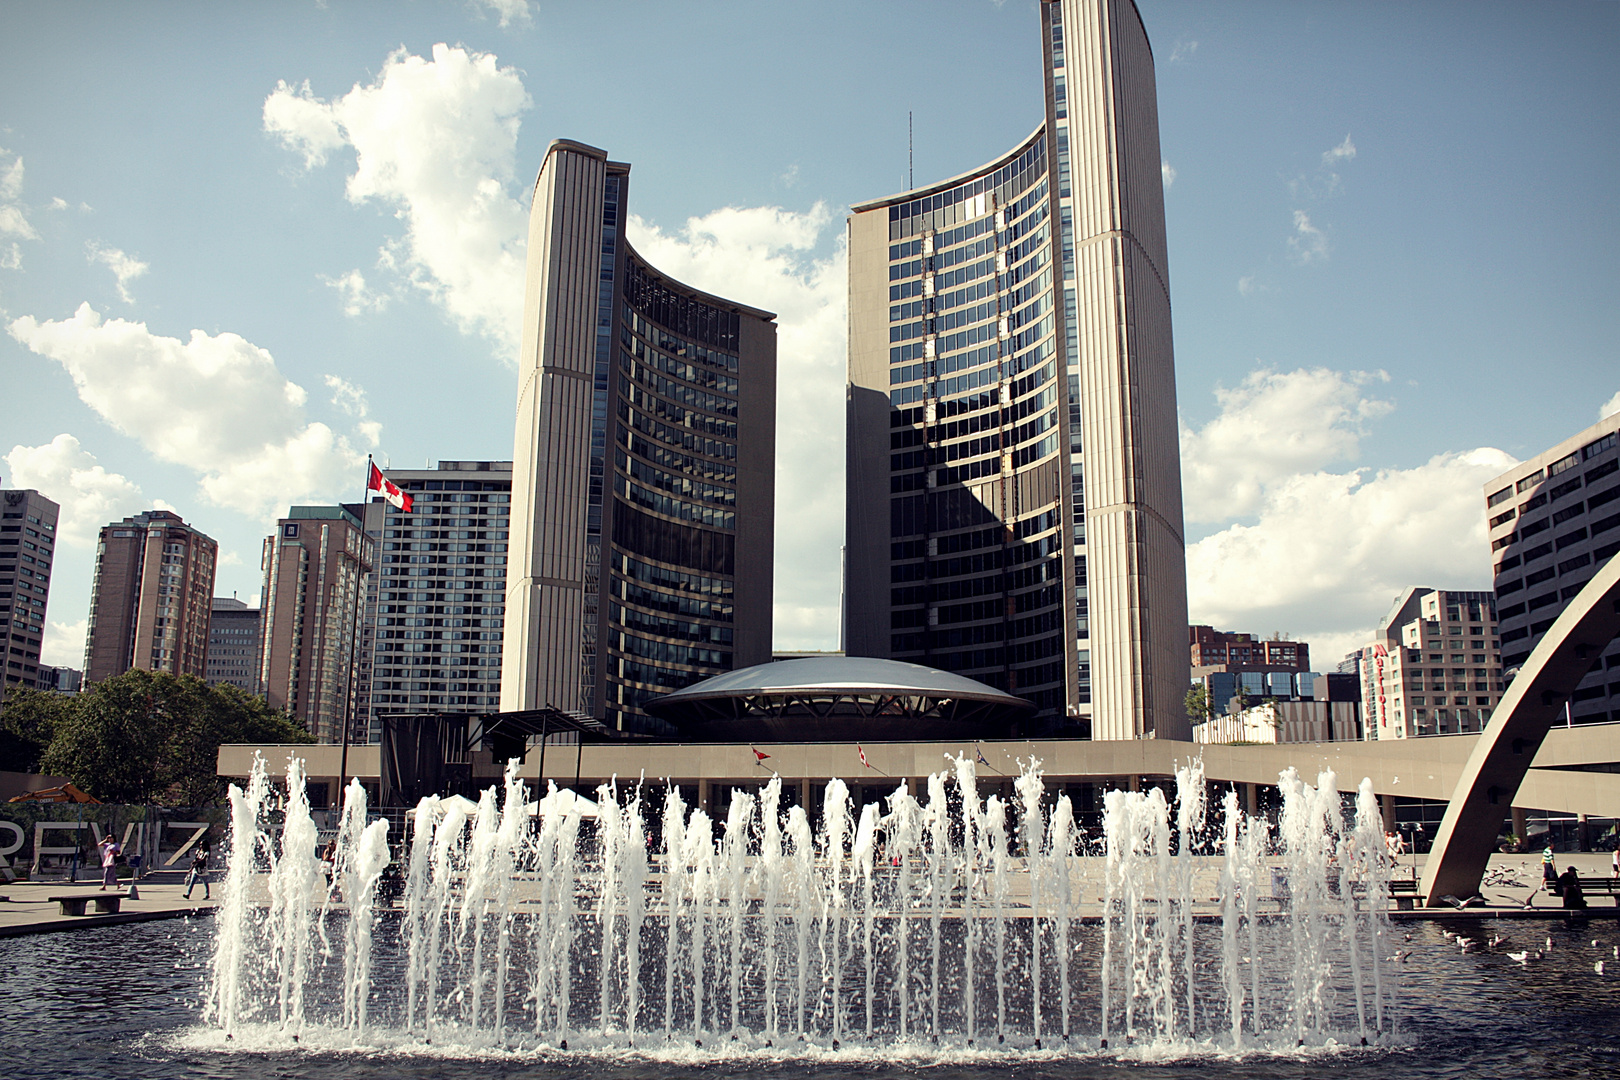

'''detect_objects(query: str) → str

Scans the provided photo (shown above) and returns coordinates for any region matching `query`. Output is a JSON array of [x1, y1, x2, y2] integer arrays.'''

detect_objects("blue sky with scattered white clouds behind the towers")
[[0, 0, 1620, 669]]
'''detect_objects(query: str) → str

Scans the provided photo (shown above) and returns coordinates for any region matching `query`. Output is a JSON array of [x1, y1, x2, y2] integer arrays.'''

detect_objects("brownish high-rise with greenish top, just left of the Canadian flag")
[[259, 507, 374, 743]]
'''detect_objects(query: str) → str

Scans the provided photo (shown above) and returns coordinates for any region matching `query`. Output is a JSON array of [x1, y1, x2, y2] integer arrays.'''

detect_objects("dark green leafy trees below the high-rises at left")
[[0, 669, 314, 806]]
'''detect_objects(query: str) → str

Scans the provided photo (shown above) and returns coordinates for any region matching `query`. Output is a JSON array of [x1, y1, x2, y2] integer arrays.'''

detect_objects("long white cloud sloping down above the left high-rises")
[[8, 303, 372, 520]]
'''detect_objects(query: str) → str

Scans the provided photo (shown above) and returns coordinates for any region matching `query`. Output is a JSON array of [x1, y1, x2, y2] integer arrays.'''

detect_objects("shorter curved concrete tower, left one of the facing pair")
[[501, 141, 776, 732]]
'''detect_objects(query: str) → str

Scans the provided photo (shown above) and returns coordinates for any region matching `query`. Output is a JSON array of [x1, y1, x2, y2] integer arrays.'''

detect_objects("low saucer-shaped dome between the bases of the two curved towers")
[[643, 656, 1035, 743]]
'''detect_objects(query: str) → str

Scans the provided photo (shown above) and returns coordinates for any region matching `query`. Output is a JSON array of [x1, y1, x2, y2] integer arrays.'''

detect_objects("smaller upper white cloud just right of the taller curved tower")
[[1181, 368, 1393, 521]]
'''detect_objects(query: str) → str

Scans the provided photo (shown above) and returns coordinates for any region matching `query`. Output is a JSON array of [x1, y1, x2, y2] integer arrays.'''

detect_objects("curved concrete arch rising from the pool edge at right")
[[1419, 557, 1620, 905]]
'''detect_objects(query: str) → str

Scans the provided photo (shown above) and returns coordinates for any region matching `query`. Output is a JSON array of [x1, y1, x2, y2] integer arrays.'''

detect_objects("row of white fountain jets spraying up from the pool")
[[207, 756, 1396, 1054]]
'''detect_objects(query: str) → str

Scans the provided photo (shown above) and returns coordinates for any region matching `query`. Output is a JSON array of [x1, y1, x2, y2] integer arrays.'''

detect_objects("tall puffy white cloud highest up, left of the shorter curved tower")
[[264, 44, 531, 359]]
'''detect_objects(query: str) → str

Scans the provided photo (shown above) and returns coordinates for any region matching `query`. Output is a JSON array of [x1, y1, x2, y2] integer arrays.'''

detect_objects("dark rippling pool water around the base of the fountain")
[[0, 913, 1620, 1080]]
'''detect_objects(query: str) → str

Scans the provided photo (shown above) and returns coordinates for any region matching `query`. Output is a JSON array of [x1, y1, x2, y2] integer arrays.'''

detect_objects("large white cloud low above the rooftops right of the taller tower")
[[1187, 447, 1515, 669]]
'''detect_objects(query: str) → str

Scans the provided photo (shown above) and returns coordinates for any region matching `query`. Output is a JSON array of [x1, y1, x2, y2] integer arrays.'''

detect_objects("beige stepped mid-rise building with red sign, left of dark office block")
[[1361, 588, 1505, 738]]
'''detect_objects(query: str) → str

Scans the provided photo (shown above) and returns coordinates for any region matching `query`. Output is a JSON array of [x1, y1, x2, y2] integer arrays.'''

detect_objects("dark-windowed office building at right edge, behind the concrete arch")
[[1486, 413, 1620, 724]]
